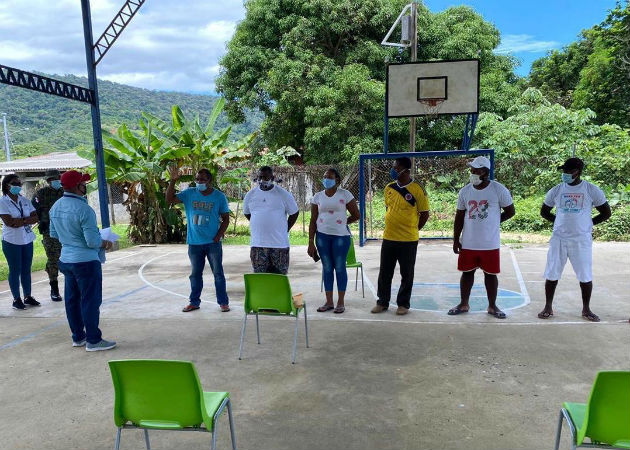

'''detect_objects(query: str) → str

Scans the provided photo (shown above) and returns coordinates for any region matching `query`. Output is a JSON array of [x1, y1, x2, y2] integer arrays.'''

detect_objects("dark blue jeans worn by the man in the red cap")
[[59, 261, 103, 344]]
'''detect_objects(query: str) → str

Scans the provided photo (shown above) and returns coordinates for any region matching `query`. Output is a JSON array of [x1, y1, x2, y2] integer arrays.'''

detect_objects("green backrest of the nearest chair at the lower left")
[[109, 359, 203, 428]]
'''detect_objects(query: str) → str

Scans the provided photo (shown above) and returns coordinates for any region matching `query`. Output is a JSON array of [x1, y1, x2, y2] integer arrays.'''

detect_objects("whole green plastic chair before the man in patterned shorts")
[[238, 273, 308, 364]]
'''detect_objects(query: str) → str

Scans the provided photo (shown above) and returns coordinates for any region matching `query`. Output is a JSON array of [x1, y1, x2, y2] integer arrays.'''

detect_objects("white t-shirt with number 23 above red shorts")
[[457, 180, 513, 250]]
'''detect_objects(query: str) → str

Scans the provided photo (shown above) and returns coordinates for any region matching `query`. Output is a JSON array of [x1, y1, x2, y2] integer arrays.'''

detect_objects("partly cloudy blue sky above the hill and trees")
[[0, 0, 615, 92]]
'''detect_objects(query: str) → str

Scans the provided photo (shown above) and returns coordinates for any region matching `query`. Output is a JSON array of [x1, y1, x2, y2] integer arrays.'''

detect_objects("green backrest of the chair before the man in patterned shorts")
[[243, 273, 295, 314]]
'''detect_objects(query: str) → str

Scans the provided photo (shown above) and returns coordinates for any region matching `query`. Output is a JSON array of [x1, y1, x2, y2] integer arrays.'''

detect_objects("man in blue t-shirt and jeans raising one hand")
[[166, 167, 230, 312]]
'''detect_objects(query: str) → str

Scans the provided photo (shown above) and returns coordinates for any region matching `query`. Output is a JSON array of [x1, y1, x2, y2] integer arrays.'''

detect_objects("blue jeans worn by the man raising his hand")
[[188, 242, 230, 306]]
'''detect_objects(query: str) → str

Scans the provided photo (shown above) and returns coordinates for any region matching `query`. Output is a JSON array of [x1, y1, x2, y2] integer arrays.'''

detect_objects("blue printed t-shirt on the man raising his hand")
[[177, 188, 230, 245]]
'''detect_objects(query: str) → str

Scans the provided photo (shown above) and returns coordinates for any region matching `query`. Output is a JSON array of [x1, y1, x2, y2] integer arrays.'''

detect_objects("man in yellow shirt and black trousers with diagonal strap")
[[372, 158, 429, 316]]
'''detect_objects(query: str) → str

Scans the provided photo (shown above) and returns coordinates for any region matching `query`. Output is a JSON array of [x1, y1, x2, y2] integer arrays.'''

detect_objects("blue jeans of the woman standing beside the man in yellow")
[[315, 231, 351, 292]]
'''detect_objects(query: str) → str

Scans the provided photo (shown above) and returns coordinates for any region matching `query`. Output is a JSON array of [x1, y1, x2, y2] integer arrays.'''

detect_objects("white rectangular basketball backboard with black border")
[[386, 59, 479, 117]]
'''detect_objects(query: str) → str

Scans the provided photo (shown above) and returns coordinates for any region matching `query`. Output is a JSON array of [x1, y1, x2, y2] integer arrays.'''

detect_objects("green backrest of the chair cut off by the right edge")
[[578, 371, 630, 445]]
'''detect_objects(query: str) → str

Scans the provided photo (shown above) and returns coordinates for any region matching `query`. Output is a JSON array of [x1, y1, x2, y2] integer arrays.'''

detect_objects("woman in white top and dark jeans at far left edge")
[[0, 174, 39, 310]]
